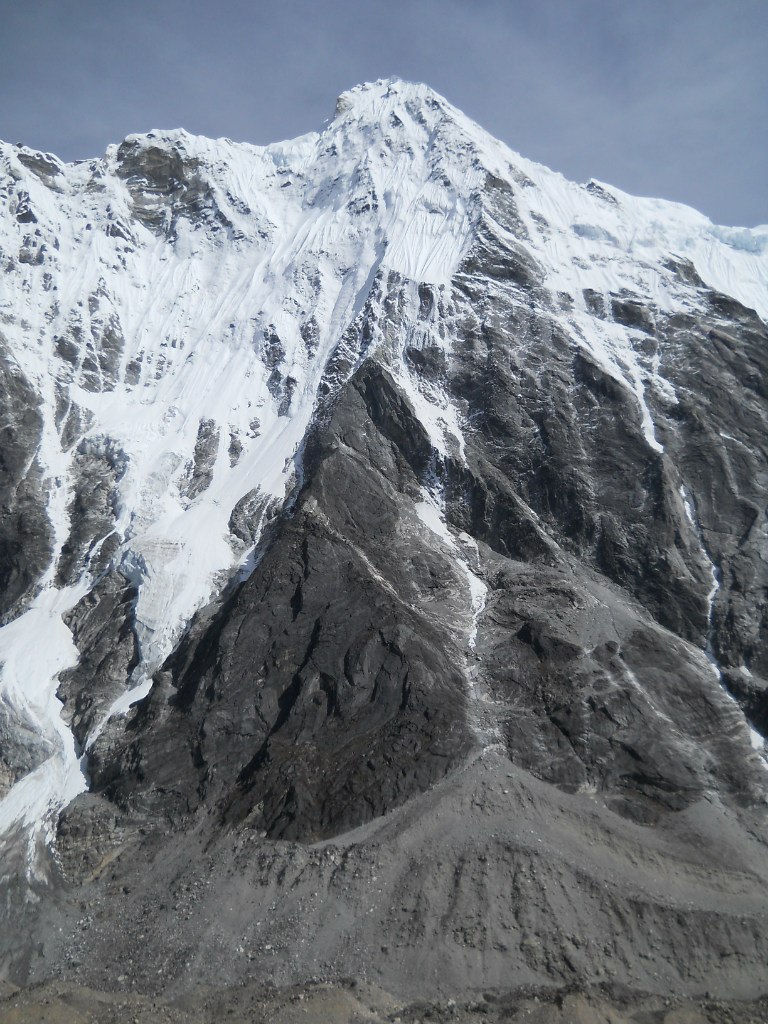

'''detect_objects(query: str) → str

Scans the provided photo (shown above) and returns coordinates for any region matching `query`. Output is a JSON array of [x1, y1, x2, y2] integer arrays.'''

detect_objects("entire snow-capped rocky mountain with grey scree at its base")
[[0, 80, 768, 998]]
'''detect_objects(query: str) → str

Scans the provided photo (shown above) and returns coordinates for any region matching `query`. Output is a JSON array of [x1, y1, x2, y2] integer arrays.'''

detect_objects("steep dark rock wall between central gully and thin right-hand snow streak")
[[449, 264, 711, 644]]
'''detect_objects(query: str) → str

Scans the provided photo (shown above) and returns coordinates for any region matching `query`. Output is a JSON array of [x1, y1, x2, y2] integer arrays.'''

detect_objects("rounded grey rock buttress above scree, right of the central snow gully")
[[486, 566, 763, 824]]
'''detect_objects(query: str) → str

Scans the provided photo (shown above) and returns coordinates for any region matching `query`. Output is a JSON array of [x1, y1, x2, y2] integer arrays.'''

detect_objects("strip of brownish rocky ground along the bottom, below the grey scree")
[[0, 980, 768, 1024]]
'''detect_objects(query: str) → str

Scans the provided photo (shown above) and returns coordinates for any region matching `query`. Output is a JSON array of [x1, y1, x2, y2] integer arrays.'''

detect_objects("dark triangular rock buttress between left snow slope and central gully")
[[93, 367, 470, 839]]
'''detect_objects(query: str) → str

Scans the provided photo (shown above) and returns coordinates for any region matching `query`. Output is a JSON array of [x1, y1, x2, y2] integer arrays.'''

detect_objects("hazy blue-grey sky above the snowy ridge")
[[0, 0, 768, 226]]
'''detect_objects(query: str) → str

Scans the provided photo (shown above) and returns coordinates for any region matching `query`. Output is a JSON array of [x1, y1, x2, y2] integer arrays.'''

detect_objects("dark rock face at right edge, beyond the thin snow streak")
[[657, 299, 768, 680]]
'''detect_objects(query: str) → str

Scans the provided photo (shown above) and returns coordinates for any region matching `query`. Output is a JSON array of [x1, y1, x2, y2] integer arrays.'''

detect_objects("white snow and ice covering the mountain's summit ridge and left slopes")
[[0, 80, 768, 868]]
